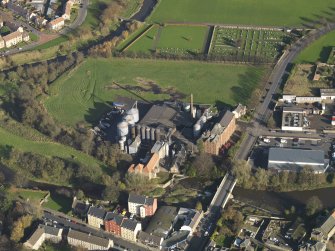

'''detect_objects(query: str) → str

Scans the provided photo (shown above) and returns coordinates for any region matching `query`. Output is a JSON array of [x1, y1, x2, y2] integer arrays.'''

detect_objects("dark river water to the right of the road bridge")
[[233, 187, 335, 211]]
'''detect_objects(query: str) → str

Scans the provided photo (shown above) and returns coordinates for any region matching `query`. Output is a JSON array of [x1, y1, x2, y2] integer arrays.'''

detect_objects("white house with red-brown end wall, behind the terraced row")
[[128, 193, 157, 218]]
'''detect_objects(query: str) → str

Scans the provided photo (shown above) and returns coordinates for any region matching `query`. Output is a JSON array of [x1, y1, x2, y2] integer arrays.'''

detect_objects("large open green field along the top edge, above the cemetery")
[[150, 0, 335, 26]]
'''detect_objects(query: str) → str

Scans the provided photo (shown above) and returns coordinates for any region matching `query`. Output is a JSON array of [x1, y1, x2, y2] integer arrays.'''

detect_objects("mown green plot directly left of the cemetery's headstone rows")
[[129, 25, 208, 55]]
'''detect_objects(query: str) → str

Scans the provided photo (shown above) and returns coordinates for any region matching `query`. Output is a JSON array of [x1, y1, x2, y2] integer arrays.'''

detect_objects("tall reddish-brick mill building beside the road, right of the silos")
[[202, 111, 236, 155]]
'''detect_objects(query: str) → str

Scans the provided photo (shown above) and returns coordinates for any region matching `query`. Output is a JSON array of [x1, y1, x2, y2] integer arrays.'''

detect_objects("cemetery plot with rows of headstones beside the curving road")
[[210, 27, 286, 61]]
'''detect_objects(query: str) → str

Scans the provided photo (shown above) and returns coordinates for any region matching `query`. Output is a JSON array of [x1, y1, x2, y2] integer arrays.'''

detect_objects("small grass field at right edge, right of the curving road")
[[295, 31, 335, 63]]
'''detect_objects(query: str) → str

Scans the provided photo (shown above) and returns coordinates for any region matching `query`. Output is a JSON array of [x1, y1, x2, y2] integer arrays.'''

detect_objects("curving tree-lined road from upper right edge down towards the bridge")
[[235, 23, 335, 160]]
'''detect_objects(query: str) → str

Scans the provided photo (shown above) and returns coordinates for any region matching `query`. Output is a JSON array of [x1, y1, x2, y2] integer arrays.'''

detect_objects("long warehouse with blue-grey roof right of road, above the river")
[[268, 148, 328, 173]]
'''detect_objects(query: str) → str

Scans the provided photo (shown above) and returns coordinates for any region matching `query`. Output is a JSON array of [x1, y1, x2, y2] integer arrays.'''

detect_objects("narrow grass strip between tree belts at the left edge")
[[0, 127, 101, 168]]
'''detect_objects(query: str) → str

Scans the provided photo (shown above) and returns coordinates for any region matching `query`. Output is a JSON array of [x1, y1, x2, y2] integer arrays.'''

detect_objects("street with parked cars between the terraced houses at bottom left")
[[43, 209, 150, 251]]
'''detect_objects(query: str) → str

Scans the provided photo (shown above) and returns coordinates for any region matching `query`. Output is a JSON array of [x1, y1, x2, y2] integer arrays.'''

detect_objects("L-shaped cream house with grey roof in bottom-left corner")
[[24, 224, 63, 250]]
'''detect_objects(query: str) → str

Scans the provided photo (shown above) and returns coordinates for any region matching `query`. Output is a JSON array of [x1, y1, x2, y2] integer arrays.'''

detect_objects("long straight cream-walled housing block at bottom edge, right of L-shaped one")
[[67, 229, 113, 250]]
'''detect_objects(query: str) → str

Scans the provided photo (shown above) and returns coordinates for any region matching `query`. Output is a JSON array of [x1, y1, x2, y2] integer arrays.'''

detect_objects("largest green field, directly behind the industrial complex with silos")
[[45, 58, 266, 125]]
